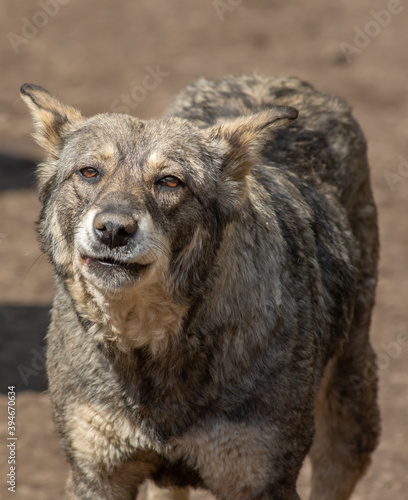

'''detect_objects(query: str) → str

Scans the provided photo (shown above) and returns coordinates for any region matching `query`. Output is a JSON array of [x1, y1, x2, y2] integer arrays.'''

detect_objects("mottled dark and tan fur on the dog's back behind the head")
[[165, 76, 372, 211]]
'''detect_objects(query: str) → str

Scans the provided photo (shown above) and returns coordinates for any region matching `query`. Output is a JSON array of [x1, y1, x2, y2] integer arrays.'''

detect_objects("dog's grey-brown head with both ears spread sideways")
[[21, 84, 297, 294]]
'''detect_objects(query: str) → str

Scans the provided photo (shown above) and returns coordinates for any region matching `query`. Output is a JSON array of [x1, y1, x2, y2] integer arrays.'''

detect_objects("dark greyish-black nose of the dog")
[[93, 210, 137, 248]]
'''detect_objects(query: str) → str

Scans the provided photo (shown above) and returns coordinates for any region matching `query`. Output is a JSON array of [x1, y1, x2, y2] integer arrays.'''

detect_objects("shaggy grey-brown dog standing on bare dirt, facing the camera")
[[21, 76, 380, 500]]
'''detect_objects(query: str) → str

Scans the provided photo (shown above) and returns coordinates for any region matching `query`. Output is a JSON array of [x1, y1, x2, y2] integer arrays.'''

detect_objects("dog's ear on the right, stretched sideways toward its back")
[[208, 106, 298, 181]]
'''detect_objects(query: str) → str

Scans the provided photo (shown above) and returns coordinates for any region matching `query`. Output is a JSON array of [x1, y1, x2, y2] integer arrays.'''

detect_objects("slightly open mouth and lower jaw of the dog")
[[80, 254, 150, 286]]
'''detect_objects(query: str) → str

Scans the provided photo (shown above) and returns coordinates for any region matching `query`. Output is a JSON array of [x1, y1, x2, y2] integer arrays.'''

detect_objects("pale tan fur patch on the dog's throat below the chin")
[[67, 274, 188, 353]]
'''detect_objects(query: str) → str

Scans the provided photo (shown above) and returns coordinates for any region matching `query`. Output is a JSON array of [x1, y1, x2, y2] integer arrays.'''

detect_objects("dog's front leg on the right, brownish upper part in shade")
[[174, 415, 313, 500]]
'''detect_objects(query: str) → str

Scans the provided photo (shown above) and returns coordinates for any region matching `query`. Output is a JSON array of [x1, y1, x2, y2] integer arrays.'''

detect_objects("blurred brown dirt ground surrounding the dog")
[[0, 0, 408, 500]]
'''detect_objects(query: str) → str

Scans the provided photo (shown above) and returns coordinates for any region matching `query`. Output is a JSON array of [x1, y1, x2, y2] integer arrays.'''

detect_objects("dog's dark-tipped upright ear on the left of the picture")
[[20, 83, 82, 158]]
